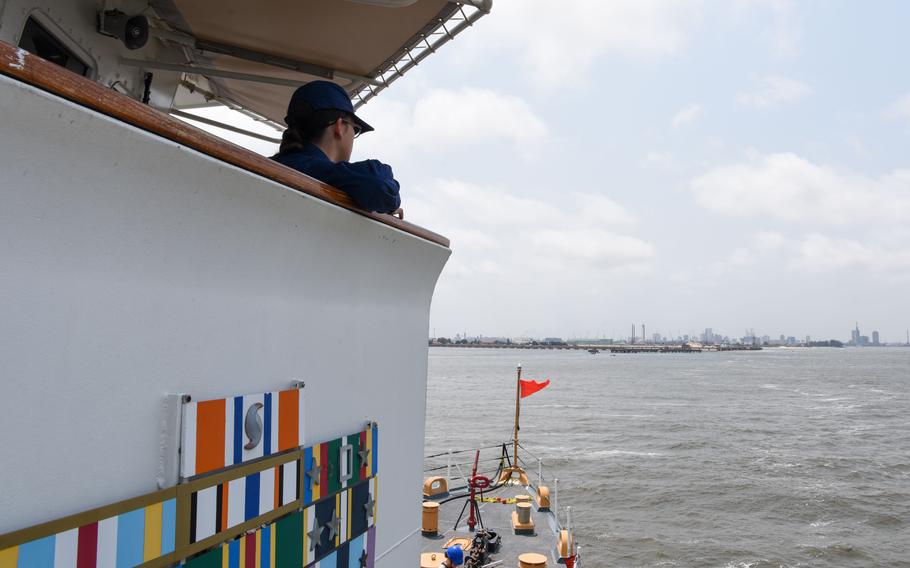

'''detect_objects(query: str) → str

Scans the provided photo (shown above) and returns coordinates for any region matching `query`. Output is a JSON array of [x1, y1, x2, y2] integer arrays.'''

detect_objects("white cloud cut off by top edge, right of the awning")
[[484, 0, 701, 87]]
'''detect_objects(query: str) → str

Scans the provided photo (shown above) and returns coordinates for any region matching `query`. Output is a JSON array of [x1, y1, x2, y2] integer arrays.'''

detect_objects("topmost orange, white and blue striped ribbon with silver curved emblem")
[[180, 389, 305, 479]]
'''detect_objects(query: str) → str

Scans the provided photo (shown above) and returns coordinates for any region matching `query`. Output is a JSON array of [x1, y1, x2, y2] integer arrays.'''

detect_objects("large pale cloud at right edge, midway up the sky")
[[689, 154, 910, 225]]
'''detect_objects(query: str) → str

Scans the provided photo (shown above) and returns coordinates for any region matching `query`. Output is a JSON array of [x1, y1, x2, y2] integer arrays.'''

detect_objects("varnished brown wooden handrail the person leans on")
[[0, 41, 449, 247]]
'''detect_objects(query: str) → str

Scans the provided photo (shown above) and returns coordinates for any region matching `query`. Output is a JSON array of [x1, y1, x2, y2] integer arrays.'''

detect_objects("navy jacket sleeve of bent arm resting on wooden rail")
[[321, 160, 401, 213]]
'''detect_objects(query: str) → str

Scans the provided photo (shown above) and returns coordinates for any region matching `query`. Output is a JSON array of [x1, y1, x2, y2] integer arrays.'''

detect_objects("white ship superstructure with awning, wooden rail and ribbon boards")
[[0, 0, 490, 568]]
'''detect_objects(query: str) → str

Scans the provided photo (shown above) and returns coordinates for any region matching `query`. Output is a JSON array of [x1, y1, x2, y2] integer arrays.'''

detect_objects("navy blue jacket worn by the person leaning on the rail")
[[272, 144, 401, 213]]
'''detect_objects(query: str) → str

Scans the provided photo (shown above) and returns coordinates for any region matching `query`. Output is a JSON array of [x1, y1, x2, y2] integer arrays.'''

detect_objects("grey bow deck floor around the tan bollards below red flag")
[[421, 485, 561, 568]]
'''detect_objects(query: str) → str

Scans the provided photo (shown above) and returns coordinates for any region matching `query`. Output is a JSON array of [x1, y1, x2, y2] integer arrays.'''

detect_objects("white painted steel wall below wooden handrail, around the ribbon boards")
[[0, 73, 450, 567]]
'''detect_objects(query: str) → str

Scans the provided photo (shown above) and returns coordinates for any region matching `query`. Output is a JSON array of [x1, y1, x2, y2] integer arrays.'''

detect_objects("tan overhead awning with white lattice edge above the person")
[[146, 0, 492, 124]]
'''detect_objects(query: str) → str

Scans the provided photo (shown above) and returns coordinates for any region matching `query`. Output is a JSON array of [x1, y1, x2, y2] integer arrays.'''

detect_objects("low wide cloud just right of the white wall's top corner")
[[408, 179, 655, 276]]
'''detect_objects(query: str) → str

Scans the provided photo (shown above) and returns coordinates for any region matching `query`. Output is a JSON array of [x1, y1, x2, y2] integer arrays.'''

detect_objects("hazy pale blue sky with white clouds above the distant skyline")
[[185, 0, 910, 342]]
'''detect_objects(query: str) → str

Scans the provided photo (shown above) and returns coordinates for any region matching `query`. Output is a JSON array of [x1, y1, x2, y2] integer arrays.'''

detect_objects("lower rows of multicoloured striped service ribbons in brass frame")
[[0, 422, 379, 568]]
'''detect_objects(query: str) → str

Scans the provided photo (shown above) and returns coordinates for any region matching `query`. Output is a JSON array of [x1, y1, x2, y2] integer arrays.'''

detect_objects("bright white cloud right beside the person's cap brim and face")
[[355, 87, 549, 161]]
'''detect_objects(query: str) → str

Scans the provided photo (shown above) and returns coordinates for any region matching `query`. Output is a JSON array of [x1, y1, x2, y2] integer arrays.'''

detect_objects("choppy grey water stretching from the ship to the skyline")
[[426, 348, 910, 568]]
